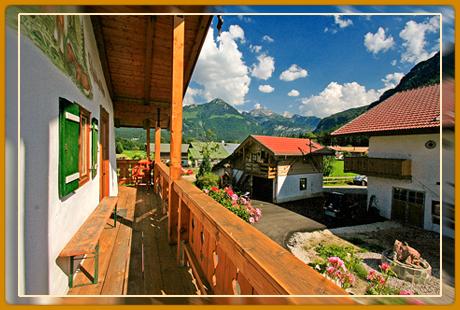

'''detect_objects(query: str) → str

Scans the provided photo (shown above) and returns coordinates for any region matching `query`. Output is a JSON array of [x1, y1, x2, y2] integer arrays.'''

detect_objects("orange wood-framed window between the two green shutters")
[[78, 108, 90, 186]]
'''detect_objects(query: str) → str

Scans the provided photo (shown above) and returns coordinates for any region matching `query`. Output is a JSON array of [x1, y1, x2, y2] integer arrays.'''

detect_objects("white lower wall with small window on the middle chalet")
[[273, 173, 323, 203]]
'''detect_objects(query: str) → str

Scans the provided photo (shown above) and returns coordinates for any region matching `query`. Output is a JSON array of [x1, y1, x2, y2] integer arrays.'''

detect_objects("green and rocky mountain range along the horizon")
[[116, 52, 446, 142]]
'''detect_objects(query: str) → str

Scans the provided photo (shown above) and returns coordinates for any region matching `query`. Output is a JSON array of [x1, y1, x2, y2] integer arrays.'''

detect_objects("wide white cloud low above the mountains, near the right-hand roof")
[[299, 82, 379, 117]]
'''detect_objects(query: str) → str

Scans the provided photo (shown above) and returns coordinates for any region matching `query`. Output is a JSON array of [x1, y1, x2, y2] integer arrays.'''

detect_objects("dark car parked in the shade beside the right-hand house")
[[323, 192, 365, 222]]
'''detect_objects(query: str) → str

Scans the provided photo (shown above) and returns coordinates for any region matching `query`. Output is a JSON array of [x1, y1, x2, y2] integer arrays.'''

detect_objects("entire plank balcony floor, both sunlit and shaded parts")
[[69, 186, 196, 295]]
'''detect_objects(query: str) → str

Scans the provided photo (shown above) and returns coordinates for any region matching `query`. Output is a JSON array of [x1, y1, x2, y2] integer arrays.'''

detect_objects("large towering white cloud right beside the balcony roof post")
[[193, 26, 251, 105]]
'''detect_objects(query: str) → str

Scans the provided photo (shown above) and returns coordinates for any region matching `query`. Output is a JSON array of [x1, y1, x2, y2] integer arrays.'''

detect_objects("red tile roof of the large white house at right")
[[332, 84, 440, 135]]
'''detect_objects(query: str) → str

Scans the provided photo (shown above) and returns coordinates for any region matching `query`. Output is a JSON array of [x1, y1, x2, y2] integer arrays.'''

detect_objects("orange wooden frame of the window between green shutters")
[[78, 106, 91, 187]]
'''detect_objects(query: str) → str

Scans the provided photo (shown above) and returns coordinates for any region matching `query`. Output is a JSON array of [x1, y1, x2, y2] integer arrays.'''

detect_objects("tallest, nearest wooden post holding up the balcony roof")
[[168, 16, 185, 244]]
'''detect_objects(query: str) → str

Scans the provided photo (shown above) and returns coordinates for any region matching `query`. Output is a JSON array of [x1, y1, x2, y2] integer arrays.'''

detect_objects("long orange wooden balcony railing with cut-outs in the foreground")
[[155, 164, 353, 303]]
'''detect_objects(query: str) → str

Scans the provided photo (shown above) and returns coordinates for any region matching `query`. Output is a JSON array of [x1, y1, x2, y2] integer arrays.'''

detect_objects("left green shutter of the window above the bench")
[[59, 98, 80, 198]]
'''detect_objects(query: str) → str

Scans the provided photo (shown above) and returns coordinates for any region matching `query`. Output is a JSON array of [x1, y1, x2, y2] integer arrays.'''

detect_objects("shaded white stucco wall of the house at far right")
[[367, 134, 440, 235]]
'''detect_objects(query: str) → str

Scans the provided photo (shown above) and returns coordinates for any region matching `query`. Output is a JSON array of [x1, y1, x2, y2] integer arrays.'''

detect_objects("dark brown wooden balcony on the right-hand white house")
[[344, 157, 412, 179]]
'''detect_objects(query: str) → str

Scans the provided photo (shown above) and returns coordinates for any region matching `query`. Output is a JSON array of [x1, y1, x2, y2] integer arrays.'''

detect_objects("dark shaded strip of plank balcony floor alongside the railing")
[[127, 186, 196, 295]]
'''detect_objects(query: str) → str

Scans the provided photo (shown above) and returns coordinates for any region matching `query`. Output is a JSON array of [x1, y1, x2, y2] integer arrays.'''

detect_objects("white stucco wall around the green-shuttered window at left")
[[17, 16, 118, 294]]
